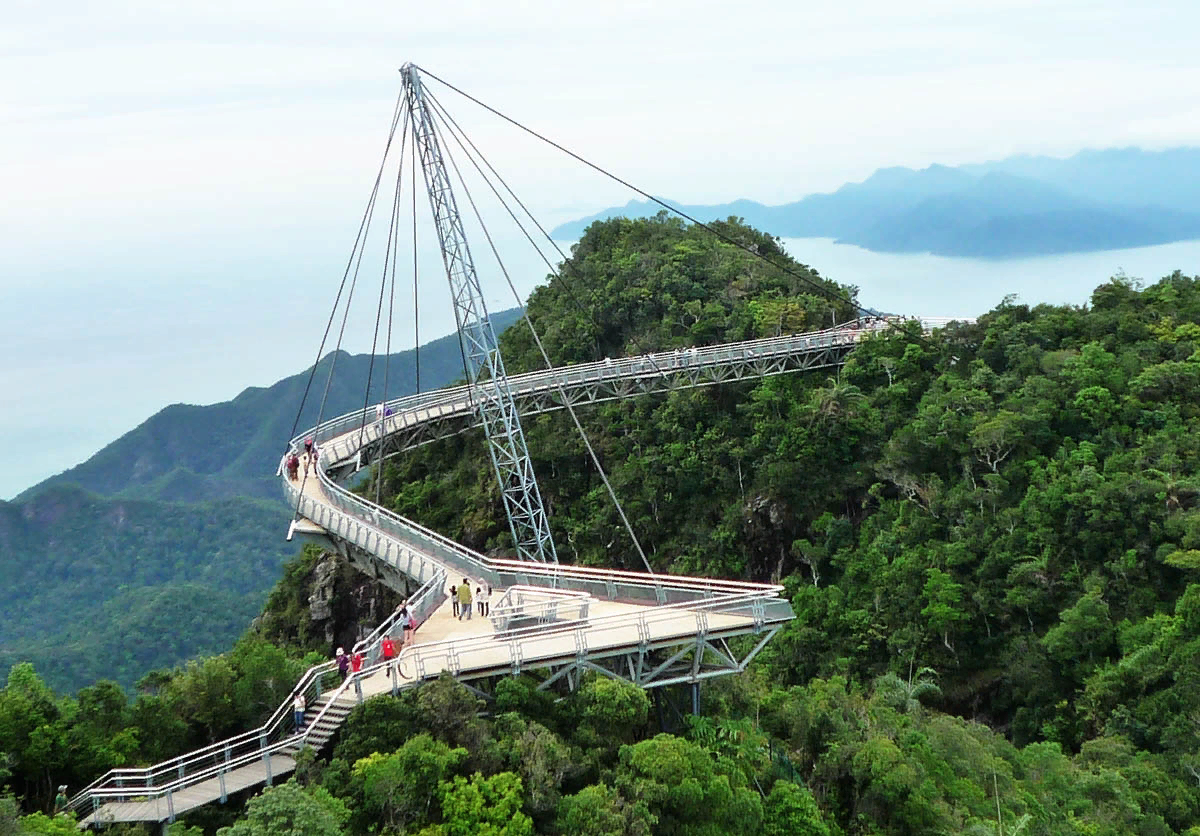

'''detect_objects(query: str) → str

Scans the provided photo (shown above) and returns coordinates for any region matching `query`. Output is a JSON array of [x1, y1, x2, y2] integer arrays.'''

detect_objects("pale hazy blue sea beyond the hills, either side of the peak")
[[7, 239, 1200, 498]]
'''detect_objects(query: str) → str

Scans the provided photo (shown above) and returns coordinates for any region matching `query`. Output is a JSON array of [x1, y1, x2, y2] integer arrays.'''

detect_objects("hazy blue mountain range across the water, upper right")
[[552, 149, 1200, 258]]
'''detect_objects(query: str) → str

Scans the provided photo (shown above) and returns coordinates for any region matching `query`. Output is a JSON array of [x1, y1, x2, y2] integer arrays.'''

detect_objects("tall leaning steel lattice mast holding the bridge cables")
[[400, 64, 558, 563]]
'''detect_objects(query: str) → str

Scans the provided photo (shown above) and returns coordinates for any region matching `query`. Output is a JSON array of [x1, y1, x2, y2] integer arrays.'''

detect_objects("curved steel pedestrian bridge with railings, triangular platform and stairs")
[[71, 318, 964, 826]]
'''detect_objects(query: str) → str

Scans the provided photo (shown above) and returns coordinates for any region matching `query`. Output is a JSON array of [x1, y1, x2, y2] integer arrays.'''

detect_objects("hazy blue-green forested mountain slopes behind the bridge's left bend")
[[0, 309, 520, 691]]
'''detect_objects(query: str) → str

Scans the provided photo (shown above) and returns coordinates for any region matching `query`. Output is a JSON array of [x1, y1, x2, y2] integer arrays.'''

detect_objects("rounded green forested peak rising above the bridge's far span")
[[502, 211, 857, 371]]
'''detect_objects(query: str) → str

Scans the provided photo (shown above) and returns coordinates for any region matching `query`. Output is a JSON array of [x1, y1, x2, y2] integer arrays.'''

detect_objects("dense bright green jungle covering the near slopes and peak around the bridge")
[[7, 218, 1200, 836]]
